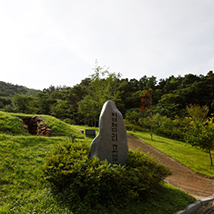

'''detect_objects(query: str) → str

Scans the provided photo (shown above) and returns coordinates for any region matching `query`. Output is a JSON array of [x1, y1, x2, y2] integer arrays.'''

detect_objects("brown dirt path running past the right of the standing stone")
[[127, 134, 214, 199]]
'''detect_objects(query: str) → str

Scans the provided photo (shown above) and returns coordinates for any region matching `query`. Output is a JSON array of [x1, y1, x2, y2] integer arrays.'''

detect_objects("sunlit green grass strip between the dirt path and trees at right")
[[129, 131, 214, 177]]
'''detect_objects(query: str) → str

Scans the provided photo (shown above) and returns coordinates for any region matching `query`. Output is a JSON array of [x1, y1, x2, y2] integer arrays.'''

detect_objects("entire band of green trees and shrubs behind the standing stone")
[[0, 65, 214, 165]]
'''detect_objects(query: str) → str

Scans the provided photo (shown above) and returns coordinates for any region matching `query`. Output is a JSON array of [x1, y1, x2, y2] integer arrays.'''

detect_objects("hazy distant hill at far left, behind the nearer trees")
[[0, 81, 40, 97]]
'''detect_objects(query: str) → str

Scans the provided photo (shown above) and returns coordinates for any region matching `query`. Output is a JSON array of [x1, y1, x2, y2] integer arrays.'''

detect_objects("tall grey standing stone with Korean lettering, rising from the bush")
[[90, 100, 128, 165]]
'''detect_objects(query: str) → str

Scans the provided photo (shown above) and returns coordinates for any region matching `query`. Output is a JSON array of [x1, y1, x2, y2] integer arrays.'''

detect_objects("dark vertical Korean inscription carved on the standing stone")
[[111, 113, 118, 164]]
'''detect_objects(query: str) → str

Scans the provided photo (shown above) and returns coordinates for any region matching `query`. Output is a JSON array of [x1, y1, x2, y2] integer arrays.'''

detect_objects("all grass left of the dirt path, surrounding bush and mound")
[[0, 111, 195, 214]]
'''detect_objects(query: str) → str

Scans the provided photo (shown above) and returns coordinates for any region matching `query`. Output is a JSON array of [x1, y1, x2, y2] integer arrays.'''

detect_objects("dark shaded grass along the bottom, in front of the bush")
[[46, 184, 196, 214]]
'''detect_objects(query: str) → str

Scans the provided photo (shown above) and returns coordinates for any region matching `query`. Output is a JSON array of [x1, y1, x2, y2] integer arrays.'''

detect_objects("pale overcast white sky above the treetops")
[[0, 0, 214, 90]]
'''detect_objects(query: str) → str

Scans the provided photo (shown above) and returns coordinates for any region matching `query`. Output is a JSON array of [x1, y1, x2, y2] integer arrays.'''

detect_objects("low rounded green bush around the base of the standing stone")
[[42, 143, 171, 211]]
